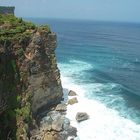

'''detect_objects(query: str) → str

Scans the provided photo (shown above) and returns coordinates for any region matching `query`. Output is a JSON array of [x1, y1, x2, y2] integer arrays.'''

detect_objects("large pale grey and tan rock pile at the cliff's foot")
[[30, 104, 77, 140]]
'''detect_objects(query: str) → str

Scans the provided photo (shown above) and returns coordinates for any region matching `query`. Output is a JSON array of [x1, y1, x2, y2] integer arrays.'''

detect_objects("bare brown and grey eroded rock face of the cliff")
[[26, 33, 63, 115]]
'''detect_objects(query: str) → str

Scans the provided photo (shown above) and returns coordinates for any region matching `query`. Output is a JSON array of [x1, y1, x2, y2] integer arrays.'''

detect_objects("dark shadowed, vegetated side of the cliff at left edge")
[[0, 45, 20, 140]]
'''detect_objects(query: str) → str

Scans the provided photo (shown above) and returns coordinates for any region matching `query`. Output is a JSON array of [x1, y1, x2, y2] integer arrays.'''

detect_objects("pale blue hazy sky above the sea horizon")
[[0, 0, 140, 22]]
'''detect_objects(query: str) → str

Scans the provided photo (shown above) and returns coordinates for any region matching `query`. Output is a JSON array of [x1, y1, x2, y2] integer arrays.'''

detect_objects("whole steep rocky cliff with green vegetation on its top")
[[0, 15, 63, 140]]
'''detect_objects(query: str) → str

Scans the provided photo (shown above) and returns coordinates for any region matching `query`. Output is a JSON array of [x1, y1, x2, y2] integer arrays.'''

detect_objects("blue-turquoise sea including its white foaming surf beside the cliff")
[[25, 19, 140, 140]]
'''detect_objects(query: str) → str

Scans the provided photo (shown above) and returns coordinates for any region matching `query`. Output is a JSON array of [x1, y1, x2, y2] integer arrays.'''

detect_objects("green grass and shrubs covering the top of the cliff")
[[0, 14, 50, 41]]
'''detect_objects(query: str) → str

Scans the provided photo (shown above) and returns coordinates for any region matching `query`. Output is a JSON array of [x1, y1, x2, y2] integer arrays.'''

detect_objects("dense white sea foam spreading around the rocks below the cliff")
[[58, 60, 140, 140]]
